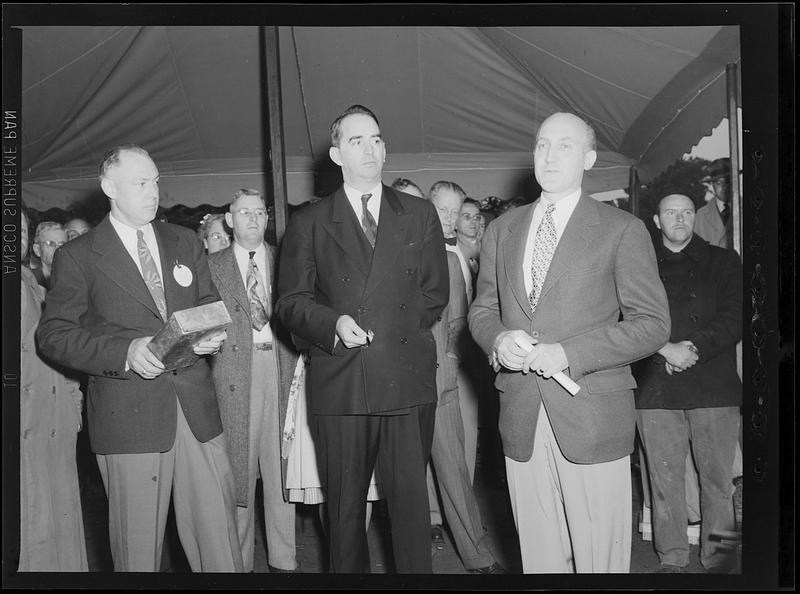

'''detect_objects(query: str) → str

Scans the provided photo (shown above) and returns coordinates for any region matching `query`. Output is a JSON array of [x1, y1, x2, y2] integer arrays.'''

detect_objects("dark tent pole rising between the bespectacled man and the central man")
[[262, 27, 289, 246]]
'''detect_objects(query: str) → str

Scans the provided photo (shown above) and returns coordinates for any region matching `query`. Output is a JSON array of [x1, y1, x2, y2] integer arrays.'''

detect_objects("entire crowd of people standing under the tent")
[[19, 105, 742, 574]]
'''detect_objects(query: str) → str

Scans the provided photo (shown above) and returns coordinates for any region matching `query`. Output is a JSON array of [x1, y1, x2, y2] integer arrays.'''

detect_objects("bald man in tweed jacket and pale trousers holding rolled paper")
[[469, 113, 670, 573]]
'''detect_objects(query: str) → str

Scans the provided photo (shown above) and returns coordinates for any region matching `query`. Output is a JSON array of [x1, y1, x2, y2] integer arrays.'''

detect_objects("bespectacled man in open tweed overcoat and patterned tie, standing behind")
[[208, 190, 297, 573]]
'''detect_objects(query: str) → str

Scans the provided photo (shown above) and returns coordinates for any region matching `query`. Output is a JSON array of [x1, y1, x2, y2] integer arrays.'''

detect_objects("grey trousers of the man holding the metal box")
[[97, 398, 243, 572]]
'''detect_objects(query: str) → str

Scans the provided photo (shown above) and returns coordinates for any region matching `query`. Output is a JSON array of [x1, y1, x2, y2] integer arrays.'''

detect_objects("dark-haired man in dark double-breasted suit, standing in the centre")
[[276, 105, 449, 573]]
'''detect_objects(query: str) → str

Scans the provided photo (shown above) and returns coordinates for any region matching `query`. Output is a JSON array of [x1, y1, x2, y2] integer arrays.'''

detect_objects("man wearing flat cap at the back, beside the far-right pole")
[[694, 157, 733, 249]]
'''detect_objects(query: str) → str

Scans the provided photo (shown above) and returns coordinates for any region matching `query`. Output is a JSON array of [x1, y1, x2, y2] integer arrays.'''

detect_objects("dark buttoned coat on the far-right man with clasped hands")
[[633, 234, 742, 409]]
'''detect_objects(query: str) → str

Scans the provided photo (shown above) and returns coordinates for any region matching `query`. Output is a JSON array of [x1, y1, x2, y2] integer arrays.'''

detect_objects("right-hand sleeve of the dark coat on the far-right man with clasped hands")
[[686, 247, 742, 363]]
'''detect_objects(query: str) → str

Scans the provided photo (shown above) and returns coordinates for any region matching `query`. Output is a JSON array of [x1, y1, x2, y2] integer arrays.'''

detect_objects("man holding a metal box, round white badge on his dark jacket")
[[37, 145, 242, 571]]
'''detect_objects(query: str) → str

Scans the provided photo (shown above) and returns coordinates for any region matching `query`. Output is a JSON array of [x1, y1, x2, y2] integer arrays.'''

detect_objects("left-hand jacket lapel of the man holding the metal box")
[[92, 217, 164, 317]]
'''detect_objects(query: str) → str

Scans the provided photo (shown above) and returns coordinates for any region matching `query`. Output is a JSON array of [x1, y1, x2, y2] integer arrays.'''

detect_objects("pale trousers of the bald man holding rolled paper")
[[506, 406, 632, 573]]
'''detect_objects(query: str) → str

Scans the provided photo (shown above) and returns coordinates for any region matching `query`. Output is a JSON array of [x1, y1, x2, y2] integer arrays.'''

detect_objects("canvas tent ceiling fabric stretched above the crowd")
[[22, 26, 740, 208]]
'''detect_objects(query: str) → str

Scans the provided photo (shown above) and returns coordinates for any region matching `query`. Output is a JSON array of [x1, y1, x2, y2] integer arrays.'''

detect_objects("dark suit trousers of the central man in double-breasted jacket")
[[313, 404, 436, 573]]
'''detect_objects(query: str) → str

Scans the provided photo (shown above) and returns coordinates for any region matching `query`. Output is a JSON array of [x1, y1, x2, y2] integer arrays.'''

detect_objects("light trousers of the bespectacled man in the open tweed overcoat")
[[236, 349, 297, 572]]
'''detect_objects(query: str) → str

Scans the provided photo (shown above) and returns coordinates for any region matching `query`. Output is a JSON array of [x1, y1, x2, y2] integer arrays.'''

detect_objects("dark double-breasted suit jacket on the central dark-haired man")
[[276, 185, 449, 414]]
